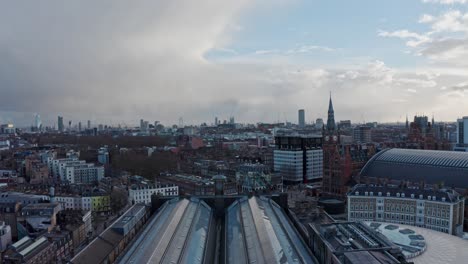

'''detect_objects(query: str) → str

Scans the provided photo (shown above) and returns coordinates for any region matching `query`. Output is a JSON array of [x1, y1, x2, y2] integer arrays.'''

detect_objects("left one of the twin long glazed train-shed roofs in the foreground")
[[119, 198, 215, 263]]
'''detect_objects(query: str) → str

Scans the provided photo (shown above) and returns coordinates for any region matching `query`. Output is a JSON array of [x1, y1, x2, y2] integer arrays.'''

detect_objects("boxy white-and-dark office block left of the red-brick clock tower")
[[273, 134, 323, 184]]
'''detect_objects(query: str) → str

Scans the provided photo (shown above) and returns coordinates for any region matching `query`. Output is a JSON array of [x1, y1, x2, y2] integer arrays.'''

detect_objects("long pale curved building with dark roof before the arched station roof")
[[347, 184, 465, 236]]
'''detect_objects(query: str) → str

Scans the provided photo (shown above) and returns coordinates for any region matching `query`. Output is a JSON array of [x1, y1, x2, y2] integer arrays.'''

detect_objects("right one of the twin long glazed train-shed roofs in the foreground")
[[224, 197, 317, 263]]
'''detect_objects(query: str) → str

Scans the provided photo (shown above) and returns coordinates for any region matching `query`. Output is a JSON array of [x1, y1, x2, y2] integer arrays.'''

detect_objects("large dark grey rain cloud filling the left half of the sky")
[[0, 0, 252, 125]]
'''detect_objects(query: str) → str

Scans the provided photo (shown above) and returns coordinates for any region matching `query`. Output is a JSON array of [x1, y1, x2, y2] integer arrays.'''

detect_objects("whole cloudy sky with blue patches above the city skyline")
[[0, 0, 468, 126]]
